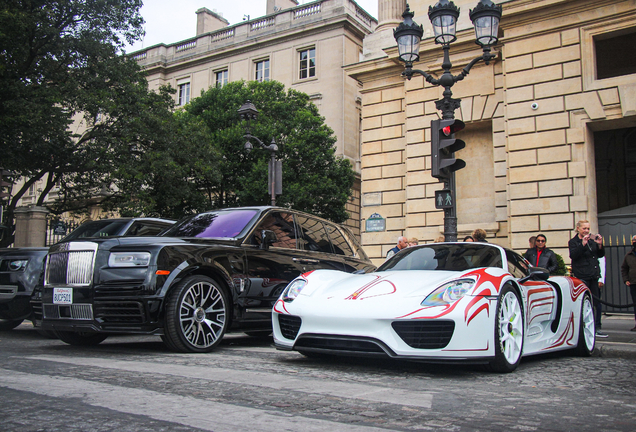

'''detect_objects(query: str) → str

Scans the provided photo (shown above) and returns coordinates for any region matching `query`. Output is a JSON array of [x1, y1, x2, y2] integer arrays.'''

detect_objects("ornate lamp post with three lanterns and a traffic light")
[[393, 0, 501, 241]]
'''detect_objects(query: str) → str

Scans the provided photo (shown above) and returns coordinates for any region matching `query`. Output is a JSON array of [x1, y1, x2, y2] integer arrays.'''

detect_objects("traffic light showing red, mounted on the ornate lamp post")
[[431, 119, 466, 180]]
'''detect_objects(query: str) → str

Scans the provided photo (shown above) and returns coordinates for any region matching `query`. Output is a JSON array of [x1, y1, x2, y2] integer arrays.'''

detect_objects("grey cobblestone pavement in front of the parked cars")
[[0, 324, 636, 432]]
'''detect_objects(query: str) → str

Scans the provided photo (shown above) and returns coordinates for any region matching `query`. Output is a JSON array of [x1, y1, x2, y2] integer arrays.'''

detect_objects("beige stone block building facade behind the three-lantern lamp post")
[[346, 0, 636, 263]]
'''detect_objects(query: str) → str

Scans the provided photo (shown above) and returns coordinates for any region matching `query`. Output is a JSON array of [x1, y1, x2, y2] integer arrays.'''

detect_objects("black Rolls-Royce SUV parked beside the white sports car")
[[43, 207, 374, 352]]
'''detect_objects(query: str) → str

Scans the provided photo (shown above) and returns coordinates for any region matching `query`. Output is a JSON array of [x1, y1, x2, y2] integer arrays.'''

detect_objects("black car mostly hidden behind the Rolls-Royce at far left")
[[0, 218, 175, 331]]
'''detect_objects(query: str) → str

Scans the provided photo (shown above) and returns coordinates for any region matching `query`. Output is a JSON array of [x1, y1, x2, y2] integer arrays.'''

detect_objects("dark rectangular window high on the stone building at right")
[[594, 28, 636, 79]]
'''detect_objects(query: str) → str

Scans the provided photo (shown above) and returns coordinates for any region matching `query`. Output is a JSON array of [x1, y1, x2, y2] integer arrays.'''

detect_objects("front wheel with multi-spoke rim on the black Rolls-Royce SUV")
[[162, 275, 232, 353]]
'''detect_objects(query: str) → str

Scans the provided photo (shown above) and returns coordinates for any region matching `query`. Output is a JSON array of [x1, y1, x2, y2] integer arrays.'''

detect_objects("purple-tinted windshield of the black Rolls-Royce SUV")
[[162, 210, 258, 238]]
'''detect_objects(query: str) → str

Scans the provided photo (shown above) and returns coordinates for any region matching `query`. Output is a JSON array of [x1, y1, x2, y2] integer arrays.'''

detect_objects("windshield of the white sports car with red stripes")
[[378, 243, 502, 271]]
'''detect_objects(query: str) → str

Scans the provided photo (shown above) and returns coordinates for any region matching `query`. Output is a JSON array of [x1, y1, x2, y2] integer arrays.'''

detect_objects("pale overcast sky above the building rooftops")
[[126, 0, 378, 52]]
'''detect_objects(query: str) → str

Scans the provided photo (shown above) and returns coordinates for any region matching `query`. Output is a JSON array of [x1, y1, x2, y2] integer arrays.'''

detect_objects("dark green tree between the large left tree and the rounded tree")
[[102, 110, 220, 219]]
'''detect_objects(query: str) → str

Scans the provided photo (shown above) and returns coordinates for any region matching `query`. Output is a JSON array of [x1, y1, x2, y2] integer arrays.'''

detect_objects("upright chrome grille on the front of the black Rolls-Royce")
[[46, 251, 95, 286]]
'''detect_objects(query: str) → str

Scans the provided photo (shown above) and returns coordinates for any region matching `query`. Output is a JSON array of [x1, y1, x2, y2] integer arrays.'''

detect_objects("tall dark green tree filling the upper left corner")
[[0, 0, 180, 245]]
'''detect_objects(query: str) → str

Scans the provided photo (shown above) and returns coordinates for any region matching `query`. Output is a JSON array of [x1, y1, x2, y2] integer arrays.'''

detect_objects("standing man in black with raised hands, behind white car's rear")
[[568, 220, 607, 338]]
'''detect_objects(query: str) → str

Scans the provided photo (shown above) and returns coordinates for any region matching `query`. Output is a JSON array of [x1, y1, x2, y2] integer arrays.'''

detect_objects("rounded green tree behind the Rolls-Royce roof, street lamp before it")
[[180, 81, 355, 222]]
